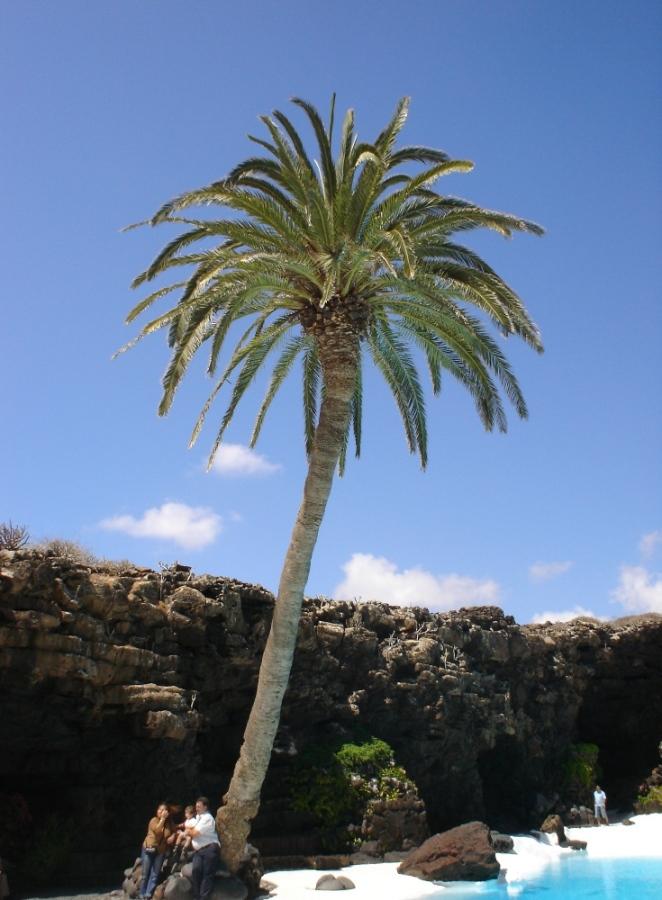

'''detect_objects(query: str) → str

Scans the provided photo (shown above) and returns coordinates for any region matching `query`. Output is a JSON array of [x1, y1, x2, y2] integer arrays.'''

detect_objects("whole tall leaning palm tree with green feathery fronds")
[[127, 97, 542, 870]]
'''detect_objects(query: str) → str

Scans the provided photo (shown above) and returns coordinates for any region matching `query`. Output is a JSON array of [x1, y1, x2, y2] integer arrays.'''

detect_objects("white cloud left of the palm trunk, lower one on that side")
[[100, 503, 223, 550]]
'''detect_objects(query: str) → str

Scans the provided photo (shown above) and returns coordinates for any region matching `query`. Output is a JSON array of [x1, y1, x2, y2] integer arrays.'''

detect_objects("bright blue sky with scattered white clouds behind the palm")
[[0, 0, 662, 621]]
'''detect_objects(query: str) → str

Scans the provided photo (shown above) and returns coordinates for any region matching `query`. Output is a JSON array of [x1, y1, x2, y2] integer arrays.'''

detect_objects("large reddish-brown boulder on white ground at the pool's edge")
[[398, 822, 501, 881]]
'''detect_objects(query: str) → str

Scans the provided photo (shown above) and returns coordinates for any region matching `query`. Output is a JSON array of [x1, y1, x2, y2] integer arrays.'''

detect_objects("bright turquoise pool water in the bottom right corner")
[[428, 847, 662, 900]]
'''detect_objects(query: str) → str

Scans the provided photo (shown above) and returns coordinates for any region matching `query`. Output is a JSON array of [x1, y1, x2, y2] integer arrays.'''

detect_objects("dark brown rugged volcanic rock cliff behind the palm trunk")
[[0, 550, 662, 873]]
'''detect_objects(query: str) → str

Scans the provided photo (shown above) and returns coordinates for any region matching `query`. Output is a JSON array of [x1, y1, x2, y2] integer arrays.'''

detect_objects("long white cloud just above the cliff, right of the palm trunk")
[[333, 553, 500, 612]]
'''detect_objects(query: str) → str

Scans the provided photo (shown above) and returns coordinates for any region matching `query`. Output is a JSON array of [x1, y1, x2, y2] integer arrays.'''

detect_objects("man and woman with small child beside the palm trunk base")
[[140, 797, 221, 900]]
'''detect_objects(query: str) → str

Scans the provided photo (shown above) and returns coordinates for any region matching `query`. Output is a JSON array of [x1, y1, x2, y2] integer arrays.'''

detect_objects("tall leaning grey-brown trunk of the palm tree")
[[216, 326, 359, 872]]
